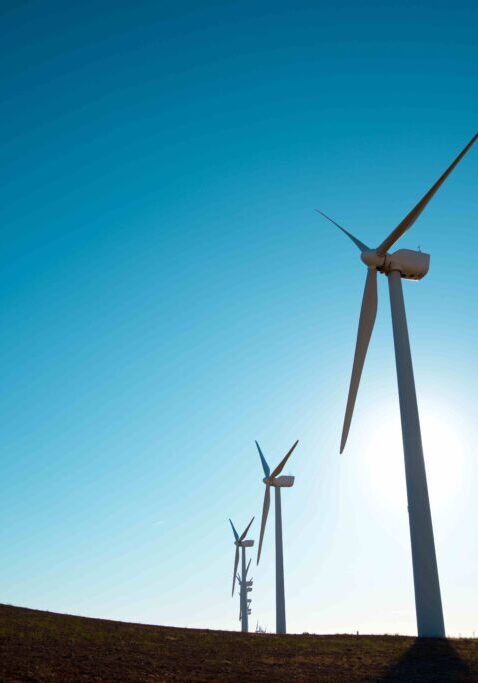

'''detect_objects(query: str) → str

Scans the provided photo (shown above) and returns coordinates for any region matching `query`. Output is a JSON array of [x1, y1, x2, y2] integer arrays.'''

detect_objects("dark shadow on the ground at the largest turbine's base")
[[379, 638, 476, 683]]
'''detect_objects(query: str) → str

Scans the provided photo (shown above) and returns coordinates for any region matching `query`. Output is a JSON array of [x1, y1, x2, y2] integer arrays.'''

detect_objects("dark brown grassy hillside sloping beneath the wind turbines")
[[0, 605, 478, 683]]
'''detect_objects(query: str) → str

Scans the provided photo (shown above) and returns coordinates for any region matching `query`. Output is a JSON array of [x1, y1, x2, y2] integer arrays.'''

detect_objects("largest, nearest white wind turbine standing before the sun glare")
[[319, 134, 478, 638]]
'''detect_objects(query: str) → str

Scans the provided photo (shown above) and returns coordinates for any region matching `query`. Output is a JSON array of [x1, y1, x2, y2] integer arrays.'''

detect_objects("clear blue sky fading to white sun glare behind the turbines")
[[0, 2, 478, 635]]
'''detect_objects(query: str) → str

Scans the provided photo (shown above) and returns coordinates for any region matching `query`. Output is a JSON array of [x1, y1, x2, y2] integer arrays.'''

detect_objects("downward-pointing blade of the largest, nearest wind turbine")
[[340, 268, 377, 453]]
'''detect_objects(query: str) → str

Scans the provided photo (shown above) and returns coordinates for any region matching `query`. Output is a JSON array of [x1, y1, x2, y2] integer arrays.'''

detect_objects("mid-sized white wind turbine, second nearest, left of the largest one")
[[256, 441, 299, 633]]
